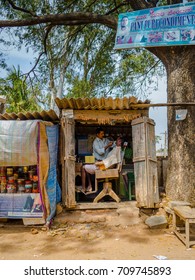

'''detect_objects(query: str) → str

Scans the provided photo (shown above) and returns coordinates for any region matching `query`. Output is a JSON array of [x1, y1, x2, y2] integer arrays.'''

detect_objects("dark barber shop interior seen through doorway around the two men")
[[75, 122, 135, 203]]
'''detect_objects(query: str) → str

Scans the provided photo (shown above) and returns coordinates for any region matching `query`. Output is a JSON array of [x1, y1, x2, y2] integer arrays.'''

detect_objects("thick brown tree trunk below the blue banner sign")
[[153, 46, 195, 206]]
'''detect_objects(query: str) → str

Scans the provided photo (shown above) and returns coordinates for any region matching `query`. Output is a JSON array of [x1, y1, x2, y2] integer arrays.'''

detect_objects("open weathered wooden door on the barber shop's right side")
[[132, 117, 159, 208]]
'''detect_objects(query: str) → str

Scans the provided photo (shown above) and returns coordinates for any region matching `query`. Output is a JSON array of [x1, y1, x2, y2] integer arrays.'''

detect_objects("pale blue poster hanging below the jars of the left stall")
[[0, 193, 43, 219]]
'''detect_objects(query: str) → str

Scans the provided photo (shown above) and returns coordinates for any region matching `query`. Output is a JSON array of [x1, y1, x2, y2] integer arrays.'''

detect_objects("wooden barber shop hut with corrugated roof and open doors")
[[55, 97, 159, 209]]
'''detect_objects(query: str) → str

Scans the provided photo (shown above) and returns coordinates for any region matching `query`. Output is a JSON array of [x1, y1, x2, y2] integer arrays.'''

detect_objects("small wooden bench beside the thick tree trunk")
[[173, 206, 195, 248]]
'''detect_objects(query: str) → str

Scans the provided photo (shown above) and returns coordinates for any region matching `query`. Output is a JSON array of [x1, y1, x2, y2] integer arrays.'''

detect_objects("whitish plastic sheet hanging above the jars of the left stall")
[[0, 120, 39, 166]]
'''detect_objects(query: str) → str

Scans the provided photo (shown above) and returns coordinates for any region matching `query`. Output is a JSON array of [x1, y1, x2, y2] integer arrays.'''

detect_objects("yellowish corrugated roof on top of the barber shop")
[[55, 96, 150, 110]]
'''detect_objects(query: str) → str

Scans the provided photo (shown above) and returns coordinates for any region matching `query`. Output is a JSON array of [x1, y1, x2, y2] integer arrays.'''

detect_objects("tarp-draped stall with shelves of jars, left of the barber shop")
[[0, 110, 61, 224]]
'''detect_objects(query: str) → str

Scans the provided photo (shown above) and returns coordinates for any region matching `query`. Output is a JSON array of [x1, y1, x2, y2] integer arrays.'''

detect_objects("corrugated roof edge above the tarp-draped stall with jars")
[[0, 110, 59, 122]]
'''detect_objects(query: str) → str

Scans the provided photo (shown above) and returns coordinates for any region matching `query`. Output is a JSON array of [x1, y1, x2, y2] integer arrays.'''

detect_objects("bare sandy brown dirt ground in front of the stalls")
[[0, 201, 195, 260]]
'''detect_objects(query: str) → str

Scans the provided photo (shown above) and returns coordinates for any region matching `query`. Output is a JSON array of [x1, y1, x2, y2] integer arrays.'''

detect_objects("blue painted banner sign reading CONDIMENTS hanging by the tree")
[[114, 3, 195, 49]]
